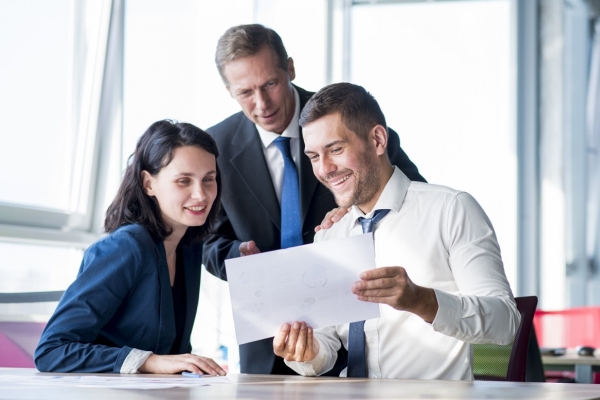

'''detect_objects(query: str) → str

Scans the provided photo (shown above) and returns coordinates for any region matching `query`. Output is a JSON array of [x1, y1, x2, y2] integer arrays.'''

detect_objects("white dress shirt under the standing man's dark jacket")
[[256, 87, 300, 204]]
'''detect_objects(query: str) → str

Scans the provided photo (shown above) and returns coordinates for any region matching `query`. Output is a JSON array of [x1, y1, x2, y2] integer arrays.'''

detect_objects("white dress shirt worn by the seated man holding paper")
[[286, 167, 520, 380]]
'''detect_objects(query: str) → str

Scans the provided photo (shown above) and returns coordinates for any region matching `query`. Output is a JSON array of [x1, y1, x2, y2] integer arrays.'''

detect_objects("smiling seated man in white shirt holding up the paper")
[[273, 83, 520, 380]]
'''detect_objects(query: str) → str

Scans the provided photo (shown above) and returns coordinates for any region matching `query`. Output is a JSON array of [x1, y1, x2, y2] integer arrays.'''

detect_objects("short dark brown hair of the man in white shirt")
[[300, 82, 387, 140]]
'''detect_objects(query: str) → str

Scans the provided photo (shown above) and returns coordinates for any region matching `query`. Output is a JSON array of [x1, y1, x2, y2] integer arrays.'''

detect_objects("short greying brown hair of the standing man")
[[215, 24, 288, 84]]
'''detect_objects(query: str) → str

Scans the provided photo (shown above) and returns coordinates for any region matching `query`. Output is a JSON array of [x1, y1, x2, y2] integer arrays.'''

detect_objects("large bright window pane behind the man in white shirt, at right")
[[351, 0, 517, 290]]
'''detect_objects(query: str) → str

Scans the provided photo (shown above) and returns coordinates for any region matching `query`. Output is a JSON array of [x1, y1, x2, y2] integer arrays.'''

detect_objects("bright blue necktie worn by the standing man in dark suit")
[[275, 136, 302, 249]]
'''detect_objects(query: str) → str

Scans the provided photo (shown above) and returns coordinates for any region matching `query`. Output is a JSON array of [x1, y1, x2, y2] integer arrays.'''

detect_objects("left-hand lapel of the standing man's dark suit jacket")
[[229, 118, 281, 229]]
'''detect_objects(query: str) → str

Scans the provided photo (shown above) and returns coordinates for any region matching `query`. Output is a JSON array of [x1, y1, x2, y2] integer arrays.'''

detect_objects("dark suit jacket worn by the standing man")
[[202, 86, 425, 374]]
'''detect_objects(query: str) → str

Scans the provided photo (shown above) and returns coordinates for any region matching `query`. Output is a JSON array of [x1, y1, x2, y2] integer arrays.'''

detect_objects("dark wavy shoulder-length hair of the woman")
[[104, 120, 221, 243]]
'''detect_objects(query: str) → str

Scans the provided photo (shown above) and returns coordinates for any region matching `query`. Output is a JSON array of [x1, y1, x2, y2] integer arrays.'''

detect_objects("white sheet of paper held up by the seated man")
[[225, 233, 379, 344]]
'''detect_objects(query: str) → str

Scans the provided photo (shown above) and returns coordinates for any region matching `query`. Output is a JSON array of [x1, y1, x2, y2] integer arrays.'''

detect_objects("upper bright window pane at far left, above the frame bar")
[[0, 0, 110, 213]]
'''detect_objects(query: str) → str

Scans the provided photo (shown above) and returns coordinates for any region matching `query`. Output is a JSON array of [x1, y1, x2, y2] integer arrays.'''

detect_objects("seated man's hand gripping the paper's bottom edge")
[[273, 321, 319, 362]]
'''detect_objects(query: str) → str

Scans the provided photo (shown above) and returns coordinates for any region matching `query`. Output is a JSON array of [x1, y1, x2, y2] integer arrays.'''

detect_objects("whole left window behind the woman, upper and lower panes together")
[[0, 0, 111, 292]]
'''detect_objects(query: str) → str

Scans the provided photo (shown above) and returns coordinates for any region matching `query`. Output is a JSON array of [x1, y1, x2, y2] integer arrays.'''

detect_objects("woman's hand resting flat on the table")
[[138, 354, 227, 376]]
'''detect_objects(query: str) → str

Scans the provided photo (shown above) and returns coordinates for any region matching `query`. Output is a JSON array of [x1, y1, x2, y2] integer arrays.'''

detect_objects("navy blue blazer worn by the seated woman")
[[34, 224, 202, 373]]
